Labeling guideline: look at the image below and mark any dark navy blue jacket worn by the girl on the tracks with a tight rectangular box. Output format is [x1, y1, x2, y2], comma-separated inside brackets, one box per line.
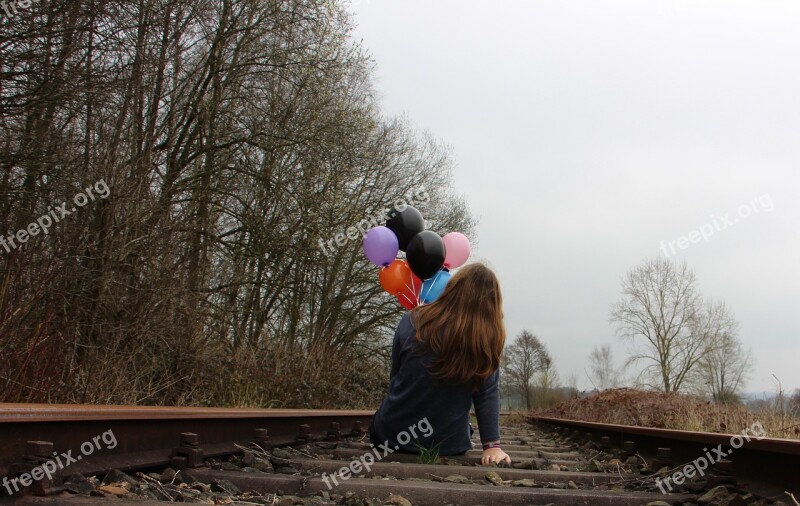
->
[370, 312, 500, 455]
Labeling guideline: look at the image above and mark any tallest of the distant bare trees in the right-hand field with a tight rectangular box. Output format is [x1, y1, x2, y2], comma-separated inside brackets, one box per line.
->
[610, 257, 711, 392]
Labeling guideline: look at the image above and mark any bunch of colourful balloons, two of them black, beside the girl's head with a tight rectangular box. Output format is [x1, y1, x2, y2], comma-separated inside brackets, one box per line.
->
[362, 206, 469, 309]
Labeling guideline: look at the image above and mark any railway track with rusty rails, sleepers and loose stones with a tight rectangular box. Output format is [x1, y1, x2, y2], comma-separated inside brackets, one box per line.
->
[0, 405, 798, 506]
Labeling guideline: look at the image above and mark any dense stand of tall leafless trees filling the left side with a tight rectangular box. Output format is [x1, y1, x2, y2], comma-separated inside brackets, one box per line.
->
[0, 0, 473, 407]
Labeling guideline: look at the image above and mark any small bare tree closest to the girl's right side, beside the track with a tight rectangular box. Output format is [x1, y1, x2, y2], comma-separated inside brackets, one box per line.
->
[502, 330, 553, 410]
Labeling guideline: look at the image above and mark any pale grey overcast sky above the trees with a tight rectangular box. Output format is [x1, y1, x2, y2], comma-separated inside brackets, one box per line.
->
[351, 0, 800, 392]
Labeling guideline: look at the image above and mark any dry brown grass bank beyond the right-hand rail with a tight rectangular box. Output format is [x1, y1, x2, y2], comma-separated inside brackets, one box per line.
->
[536, 388, 800, 439]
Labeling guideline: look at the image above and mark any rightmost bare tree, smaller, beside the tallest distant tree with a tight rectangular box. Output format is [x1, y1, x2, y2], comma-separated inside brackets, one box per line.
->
[695, 301, 752, 403]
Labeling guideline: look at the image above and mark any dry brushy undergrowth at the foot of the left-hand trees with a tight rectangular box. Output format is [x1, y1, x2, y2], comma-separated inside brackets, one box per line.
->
[0, 304, 388, 409]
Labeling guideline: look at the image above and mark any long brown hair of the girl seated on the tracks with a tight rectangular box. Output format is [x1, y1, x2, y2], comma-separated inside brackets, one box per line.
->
[414, 263, 506, 387]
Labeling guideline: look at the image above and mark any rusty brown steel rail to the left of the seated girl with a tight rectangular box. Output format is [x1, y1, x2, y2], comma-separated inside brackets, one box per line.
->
[0, 404, 373, 482]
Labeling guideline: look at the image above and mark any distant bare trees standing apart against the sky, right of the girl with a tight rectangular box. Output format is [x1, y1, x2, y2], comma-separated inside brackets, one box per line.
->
[503, 257, 753, 409]
